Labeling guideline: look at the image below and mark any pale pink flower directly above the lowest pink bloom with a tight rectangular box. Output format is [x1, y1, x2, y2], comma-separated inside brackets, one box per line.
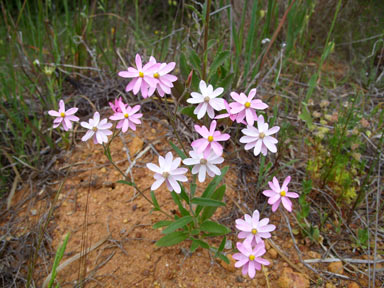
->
[236, 210, 276, 244]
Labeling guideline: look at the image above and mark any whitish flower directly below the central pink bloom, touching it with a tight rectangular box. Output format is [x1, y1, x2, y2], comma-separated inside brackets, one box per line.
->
[183, 148, 224, 183]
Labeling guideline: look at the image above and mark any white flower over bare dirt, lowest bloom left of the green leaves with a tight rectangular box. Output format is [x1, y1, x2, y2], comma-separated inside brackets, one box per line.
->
[147, 152, 188, 194]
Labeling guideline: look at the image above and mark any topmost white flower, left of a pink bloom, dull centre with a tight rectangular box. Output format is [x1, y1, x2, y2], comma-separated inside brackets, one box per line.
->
[187, 80, 225, 119]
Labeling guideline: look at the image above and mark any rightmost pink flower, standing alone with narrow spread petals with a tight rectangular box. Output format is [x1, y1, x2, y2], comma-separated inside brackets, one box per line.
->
[263, 176, 299, 212]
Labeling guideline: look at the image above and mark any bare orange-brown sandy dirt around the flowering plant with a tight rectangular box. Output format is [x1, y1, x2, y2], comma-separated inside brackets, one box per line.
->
[13, 116, 376, 288]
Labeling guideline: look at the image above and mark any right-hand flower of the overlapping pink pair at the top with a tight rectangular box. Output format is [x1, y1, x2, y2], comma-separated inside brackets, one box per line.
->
[144, 56, 177, 97]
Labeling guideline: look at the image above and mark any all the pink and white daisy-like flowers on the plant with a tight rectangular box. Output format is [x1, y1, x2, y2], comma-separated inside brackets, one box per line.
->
[48, 55, 298, 278]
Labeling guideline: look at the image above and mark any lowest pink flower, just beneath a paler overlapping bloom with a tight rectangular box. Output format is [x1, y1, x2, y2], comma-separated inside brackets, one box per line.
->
[233, 241, 269, 278]
